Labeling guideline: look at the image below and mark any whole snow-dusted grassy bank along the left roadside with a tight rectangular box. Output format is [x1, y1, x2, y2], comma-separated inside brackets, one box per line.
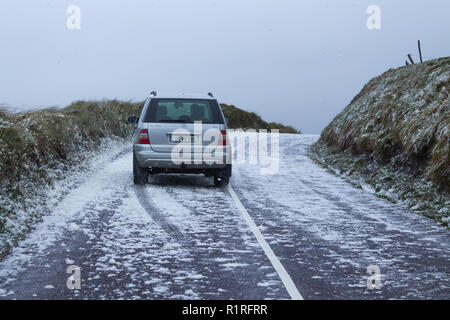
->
[0, 101, 143, 257]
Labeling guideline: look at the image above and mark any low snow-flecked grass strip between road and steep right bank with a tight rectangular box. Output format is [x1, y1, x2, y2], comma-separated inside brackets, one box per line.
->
[310, 144, 450, 227]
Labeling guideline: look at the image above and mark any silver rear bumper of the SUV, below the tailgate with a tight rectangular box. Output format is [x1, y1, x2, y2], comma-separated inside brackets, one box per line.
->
[134, 144, 231, 171]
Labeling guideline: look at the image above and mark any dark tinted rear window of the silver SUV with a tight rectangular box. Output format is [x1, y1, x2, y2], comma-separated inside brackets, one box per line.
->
[144, 98, 224, 124]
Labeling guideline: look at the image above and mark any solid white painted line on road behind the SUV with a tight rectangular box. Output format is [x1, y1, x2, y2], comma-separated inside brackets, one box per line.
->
[228, 185, 303, 300]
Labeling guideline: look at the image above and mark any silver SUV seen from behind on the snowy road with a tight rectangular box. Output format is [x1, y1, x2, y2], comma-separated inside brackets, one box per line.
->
[128, 92, 231, 186]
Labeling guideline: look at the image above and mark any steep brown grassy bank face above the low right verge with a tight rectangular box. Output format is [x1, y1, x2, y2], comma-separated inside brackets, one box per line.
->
[318, 57, 450, 189]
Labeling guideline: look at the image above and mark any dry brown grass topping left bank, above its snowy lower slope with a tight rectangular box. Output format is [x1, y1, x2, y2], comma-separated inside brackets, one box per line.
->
[0, 101, 142, 199]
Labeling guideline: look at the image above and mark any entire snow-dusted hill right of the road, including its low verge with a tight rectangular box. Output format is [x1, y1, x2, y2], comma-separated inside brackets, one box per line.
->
[312, 57, 450, 224]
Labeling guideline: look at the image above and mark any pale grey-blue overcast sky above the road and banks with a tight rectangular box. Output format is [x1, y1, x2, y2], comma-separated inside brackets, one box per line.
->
[0, 0, 450, 133]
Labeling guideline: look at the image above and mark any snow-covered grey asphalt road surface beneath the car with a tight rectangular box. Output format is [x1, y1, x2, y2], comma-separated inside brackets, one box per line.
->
[0, 135, 450, 299]
